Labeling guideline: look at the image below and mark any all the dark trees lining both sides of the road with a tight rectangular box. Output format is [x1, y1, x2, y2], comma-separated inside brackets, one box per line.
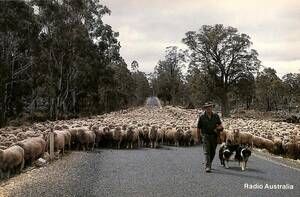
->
[0, 0, 300, 127]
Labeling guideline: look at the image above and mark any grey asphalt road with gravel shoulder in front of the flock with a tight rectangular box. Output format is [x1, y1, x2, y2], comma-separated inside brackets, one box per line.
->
[0, 146, 300, 197]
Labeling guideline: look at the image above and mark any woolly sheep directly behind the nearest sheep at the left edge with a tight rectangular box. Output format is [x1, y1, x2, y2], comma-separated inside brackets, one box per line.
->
[15, 137, 46, 165]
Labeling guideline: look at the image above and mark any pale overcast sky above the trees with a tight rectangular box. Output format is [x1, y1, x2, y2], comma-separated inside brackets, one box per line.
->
[102, 0, 300, 76]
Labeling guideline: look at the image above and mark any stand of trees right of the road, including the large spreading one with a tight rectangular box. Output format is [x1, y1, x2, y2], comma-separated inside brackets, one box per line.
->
[151, 24, 300, 116]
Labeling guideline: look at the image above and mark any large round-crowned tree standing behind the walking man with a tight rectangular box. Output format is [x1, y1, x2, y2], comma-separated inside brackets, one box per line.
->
[183, 24, 260, 116]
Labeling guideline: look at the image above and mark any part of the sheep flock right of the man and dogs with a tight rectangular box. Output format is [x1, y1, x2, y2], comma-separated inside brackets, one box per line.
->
[224, 118, 300, 159]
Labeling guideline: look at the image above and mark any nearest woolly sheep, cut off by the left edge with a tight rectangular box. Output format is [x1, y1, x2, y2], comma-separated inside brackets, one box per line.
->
[0, 145, 24, 179]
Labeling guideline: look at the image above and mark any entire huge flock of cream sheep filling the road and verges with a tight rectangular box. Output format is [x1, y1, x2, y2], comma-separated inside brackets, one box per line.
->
[0, 106, 300, 181]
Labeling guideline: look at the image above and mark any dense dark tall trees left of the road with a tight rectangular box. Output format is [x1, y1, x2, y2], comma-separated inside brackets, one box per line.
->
[0, 0, 150, 127]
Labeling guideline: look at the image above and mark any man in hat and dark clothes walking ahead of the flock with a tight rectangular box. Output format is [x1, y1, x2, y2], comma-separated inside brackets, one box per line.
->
[197, 102, 223, 172]
